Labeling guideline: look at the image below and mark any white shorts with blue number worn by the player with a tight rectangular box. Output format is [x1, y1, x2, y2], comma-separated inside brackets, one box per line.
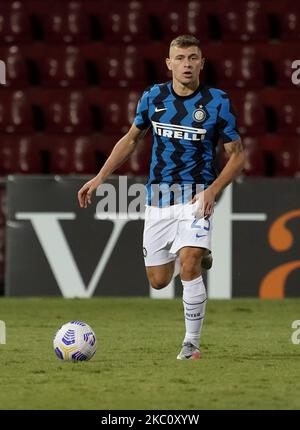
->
[143, 202, 212, 266]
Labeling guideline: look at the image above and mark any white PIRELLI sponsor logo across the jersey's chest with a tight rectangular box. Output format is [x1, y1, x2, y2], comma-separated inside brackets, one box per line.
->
[152, 121, 206, 140]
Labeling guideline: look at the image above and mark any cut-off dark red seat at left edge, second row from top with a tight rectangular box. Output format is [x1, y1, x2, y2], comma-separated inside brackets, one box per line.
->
[0, 45, 29, 88]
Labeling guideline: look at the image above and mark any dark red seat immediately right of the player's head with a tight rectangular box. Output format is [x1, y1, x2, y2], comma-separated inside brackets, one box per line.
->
[212, 44, 264, 89]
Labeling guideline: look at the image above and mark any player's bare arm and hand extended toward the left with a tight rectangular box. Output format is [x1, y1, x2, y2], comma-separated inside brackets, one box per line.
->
[78, 124, 147, 208]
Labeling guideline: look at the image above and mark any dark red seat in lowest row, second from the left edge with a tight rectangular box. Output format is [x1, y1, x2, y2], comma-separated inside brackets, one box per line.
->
[50, 136, 96, 174]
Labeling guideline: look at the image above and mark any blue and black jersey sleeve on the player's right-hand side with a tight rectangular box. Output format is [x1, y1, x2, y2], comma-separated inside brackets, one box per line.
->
[217, 94, 240, 143]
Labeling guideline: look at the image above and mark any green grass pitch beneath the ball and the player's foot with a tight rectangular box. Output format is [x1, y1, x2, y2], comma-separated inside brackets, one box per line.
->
[0, 298, 300, 410]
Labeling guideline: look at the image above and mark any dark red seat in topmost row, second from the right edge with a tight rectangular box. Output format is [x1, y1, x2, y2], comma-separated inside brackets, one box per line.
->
[218, 0, 268, 42]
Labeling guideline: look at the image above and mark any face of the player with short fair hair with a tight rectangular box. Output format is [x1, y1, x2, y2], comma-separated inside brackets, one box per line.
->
[166, 46, 204, 85]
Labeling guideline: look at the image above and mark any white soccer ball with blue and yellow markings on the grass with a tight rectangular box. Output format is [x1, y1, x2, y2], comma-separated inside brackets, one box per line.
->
[53, 321, 97, 361]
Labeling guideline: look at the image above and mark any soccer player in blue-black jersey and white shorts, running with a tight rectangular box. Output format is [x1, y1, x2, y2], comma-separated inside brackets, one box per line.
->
[78, 35, 245, 360]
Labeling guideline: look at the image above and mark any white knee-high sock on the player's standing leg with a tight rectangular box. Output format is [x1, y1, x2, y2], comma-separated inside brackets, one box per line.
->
[181, 276, 207, 347]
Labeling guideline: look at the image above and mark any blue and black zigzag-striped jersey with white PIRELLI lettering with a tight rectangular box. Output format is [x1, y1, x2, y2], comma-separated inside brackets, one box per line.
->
[134, 81, 240, 199]
